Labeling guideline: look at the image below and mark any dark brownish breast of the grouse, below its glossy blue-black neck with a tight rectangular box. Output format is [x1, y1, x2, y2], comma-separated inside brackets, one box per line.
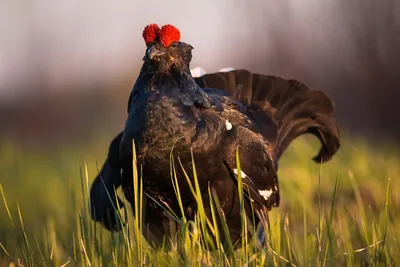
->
[122, 97, 230, 208]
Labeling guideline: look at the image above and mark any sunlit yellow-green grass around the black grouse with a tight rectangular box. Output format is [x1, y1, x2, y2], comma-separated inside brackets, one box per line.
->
[0, 133, 400, 266]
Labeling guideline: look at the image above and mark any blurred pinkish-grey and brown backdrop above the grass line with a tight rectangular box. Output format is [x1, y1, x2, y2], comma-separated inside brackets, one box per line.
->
[0, 0, 400, 149]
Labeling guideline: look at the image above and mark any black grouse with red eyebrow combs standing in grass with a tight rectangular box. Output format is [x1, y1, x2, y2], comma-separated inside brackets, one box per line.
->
[90, 24, 340, 251]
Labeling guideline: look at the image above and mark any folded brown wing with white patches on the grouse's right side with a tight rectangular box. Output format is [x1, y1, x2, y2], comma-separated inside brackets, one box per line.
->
[204, 88, 279, 209]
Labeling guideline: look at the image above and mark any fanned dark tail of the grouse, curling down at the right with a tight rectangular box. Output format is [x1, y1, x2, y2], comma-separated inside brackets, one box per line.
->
[195, 69, 340, 162]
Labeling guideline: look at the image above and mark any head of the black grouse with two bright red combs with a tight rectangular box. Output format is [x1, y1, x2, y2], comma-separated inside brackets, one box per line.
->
[143, 24, 193, 71]
